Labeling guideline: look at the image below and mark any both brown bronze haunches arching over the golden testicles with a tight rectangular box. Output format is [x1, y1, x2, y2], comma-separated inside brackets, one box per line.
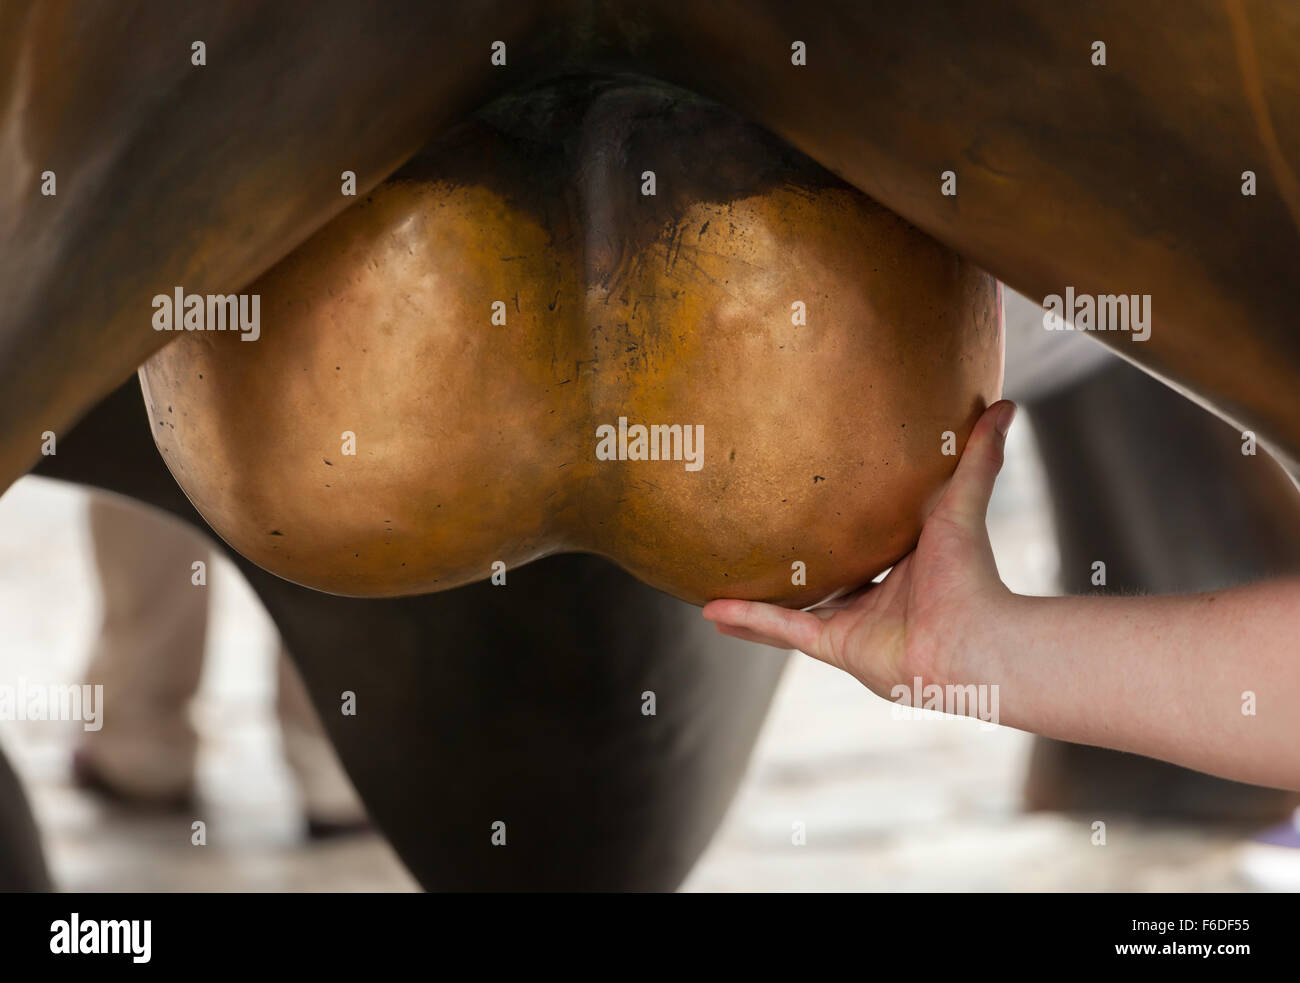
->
[0, 0, 1300, 499]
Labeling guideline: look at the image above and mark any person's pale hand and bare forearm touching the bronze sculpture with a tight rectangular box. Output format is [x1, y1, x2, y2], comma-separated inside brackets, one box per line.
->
[703, 400, 1300, 789]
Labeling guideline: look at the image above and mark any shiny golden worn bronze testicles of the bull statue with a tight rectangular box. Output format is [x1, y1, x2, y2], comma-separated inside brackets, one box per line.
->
[140, 81, 1001, 606]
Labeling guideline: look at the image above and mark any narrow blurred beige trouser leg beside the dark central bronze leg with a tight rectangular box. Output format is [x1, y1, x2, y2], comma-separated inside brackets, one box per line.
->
[276, 650, 368, 837]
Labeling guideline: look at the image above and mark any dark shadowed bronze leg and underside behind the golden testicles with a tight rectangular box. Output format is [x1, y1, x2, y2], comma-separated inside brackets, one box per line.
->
[40, 381, 785, 889]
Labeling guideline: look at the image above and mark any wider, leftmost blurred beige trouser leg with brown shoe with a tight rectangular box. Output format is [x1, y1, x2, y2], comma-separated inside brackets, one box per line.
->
[74, 495, 212, 805]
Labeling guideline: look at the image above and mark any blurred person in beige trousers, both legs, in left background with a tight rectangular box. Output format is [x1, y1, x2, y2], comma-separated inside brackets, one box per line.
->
[73, 495, 367, 837]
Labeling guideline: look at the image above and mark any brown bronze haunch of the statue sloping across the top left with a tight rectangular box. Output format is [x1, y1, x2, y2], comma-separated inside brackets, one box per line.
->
[0, 0, 543, 489]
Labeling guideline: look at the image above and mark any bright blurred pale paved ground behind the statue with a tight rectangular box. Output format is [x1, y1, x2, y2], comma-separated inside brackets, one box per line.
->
[0, 426, 1289, 891]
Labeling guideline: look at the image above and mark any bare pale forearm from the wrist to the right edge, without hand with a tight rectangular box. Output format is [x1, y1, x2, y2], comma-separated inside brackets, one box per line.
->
[963, 579, 1300, 789]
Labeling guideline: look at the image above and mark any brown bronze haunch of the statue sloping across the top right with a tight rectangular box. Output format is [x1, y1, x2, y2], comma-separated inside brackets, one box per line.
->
[626, 0, 1300, 465]
